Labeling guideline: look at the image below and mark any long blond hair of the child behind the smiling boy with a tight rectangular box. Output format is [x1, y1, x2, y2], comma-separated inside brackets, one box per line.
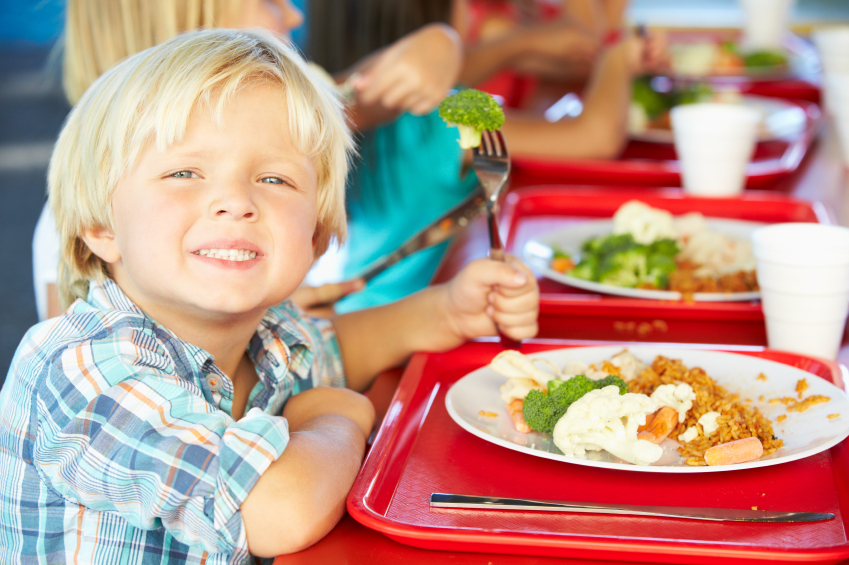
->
[62, 0, 248, 104]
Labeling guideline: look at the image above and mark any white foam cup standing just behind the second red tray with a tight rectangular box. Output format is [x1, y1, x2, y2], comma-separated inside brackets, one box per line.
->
[670, 102, 762, 196]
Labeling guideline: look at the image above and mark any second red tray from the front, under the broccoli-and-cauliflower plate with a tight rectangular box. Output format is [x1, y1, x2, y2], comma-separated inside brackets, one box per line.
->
[501, 186, 830, 345]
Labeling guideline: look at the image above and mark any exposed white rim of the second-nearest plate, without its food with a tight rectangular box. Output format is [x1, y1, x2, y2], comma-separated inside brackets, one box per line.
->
[522, 218, 766, 302]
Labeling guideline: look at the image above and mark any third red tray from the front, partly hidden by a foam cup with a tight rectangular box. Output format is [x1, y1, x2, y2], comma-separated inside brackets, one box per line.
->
[510, 100, 820, 189]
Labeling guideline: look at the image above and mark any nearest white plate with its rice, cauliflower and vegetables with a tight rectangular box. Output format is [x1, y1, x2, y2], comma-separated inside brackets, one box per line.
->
[445, 346, 849, 473]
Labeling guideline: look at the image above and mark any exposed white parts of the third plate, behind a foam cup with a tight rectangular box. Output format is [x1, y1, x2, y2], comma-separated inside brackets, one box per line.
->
[628, 95, 808, 143]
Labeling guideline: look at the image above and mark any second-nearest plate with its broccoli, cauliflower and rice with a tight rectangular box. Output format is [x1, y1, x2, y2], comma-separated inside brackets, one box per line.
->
[523, 200, 765, 302]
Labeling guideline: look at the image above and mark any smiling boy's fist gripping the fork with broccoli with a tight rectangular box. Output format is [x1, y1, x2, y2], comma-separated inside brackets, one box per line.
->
[447, 256, 539, 342]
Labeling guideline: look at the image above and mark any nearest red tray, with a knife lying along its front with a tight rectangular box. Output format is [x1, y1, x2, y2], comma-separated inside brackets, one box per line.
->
[348, 341, 849, 564]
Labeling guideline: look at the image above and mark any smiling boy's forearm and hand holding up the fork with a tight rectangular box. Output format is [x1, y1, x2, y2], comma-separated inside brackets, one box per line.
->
[333, 259, 539, 390]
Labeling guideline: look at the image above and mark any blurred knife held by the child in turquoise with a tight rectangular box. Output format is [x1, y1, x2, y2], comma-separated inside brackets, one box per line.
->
[356, 186, 486, 282]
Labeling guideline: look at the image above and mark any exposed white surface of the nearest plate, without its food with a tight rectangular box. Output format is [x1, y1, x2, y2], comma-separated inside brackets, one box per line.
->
[445, 345, 849, 473]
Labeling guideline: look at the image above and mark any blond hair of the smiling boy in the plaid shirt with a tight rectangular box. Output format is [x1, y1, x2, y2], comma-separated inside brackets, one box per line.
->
[47, 29, 353, 307]
